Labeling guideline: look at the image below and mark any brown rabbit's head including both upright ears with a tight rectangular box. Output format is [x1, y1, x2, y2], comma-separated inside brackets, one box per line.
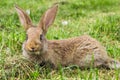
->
[15, 4, 58, 55]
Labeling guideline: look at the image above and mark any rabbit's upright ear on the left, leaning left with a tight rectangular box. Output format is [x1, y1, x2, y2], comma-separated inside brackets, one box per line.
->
[15, 6, 32, 30]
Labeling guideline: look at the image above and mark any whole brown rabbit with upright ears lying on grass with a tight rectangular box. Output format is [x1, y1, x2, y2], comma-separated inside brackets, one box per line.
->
[15, 4, 120, 69]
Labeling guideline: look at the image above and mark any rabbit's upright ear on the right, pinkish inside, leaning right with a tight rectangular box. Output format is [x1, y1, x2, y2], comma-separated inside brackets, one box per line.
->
[38, 4, 58, 34]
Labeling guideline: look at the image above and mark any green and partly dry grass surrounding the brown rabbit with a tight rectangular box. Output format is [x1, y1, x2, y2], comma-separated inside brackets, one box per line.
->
[0, 0, 120, 80]
